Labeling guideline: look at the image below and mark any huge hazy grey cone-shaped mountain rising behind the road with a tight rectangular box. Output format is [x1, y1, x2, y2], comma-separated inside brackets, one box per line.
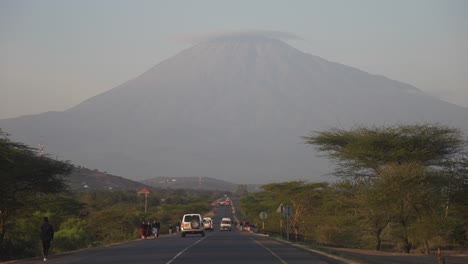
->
[0, 34, 468, 183]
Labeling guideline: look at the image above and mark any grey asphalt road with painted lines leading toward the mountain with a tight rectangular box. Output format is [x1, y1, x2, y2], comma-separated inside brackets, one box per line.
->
[15, 206, 341, 264]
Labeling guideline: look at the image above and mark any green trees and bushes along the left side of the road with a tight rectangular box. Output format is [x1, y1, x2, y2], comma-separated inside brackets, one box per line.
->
[0, 131, 219, 260]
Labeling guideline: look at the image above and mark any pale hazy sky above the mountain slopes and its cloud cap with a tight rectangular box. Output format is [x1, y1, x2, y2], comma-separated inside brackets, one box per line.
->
[0, 0, 468, 118]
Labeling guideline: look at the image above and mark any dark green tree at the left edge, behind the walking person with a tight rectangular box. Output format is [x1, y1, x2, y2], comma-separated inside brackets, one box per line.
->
[0, 131, 72, 251]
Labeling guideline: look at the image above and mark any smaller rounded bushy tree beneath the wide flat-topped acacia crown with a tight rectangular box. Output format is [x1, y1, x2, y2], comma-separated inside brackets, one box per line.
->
[376, 162, 443, 254]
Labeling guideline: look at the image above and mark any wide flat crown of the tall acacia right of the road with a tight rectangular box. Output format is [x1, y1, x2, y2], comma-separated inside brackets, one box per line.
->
[304, 124, 465, 176]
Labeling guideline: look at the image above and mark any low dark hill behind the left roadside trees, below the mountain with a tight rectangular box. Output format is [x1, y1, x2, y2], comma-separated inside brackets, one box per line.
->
[66, 167, 148, 191]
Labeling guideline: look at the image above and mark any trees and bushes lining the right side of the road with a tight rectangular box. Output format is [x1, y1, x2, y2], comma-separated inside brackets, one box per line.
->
[238, 124, 468, 254]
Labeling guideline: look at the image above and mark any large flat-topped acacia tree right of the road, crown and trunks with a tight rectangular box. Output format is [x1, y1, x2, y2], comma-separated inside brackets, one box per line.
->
[304, 124, 466, 252]
